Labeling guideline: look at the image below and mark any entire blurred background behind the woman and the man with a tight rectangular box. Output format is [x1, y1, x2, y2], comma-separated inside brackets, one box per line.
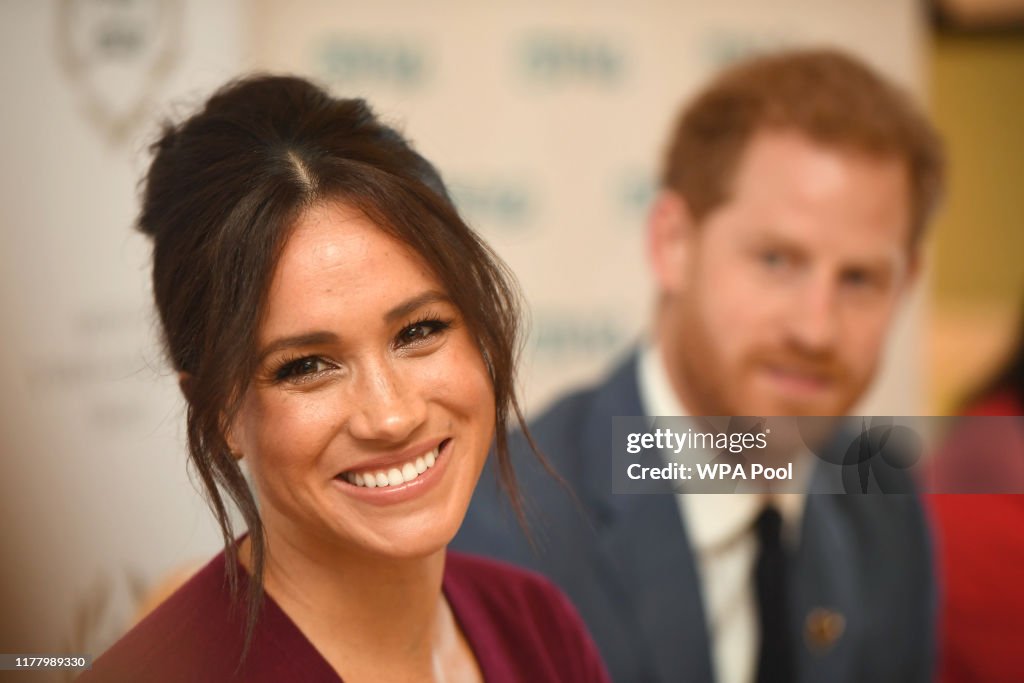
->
[0, 0, 1024, 680]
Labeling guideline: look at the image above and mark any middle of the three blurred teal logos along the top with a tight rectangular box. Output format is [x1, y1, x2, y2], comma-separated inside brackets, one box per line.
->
[519, 33, 627, 86]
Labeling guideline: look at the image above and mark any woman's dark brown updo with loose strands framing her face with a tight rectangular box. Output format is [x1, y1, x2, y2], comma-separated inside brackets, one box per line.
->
[138, 76, 528, 648]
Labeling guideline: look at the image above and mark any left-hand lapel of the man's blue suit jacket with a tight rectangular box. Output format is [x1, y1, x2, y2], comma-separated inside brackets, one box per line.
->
[582, 355, 714, 683]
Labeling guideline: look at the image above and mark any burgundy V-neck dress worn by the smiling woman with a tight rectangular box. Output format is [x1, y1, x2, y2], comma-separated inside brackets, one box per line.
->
[78, 552, 609, 683]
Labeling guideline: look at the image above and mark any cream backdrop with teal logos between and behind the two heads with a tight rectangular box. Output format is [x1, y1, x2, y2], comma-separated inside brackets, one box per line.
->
[250, 0, 923, 413]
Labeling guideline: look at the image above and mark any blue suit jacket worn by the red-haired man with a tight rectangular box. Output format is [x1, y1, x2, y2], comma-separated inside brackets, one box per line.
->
[453, 355, 935, 683]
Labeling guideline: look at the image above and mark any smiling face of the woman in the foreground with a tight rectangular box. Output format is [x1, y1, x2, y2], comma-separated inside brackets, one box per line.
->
[234, 202, 495, 561]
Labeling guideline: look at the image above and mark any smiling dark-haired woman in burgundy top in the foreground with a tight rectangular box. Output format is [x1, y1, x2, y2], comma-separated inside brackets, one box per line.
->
[81, 77, 606, 681]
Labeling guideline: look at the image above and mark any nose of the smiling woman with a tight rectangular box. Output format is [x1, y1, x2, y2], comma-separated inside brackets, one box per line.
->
[348, 359, 427, 442]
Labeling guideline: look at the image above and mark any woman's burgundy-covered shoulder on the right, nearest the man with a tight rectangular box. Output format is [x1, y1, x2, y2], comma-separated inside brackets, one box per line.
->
[444, 552, 608, 683]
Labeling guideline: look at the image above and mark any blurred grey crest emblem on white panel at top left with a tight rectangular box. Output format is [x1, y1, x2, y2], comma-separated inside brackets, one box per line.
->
[55, 0, 182, 144]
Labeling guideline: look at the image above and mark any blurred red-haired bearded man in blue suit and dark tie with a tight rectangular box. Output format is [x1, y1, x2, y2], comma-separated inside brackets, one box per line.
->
[455, 50, 942, 683]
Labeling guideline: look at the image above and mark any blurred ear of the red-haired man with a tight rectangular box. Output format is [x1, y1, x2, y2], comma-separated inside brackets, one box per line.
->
[647, 189, 696, 294]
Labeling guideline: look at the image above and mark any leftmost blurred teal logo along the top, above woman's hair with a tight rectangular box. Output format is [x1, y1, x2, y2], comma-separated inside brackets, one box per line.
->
[313, 35, 429, 89]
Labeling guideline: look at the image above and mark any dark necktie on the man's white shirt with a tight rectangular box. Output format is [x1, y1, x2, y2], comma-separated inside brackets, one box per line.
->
[754, 505, 796, 683]
